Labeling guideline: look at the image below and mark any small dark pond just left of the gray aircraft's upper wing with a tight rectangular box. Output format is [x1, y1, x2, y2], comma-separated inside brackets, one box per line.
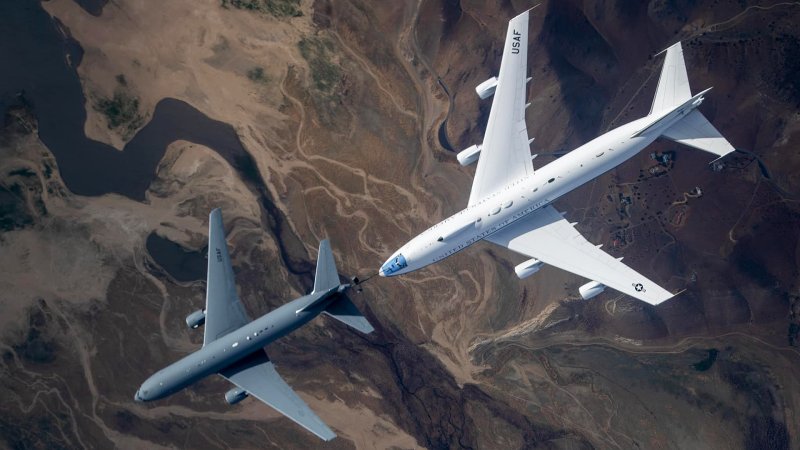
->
[147, 233, 208, 281]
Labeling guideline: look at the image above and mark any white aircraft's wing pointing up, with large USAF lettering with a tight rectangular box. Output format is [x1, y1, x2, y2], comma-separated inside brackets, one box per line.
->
[469, 11, 533, 206]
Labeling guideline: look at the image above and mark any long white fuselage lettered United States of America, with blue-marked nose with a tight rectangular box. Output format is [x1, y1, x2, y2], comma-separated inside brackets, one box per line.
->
[379, 90, 707, 276]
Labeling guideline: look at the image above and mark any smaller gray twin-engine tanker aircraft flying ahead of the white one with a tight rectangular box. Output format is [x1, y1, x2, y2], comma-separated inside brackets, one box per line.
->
[134, 209, 373, 441]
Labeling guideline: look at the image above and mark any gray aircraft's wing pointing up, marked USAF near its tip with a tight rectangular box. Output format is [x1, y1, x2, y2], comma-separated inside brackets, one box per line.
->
[203, 208, 250, 345]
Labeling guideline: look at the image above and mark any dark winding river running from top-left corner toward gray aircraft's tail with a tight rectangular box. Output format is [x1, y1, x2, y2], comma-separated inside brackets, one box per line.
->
[0, 0, 313, 285]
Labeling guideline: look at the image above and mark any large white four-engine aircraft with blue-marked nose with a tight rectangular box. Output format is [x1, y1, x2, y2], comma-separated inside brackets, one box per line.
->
[379, 11, 734, 305]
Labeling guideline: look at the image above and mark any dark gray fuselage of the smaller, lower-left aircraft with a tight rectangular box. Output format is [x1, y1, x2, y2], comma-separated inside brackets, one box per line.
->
[134, 285, 347, 401]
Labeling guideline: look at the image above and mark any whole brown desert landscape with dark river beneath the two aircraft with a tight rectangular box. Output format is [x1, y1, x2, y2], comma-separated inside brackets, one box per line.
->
[0, 0, 800, 449]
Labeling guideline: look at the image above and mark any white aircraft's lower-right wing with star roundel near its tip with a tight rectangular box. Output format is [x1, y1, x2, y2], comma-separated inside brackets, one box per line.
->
[485, 206, 673, 305]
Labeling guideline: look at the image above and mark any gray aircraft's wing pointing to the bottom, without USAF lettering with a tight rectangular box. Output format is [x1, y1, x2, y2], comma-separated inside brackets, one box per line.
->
[220, 350, 336, 441]
